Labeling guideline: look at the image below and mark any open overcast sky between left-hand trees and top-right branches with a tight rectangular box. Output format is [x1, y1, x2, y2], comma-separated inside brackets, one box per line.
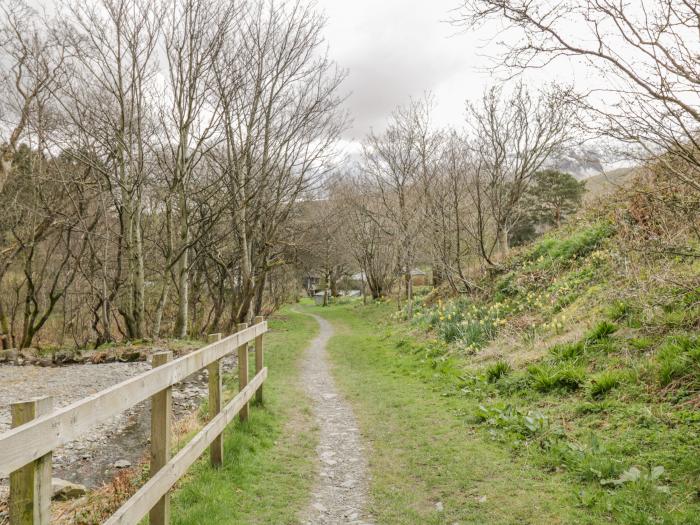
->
[316, 0, 588, 145]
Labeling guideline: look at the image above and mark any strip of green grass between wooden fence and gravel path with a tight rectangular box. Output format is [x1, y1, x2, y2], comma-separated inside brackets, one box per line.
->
[172, 309, 317, 525]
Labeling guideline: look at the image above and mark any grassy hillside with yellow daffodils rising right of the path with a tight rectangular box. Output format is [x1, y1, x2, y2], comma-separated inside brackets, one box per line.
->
[396, 183, 700, 523]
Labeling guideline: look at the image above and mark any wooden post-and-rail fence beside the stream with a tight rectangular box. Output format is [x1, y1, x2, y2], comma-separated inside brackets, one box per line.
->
[0, 317, 267, 525]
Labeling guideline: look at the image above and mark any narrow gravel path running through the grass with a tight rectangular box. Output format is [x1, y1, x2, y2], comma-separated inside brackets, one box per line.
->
[301, 314, 369, 525]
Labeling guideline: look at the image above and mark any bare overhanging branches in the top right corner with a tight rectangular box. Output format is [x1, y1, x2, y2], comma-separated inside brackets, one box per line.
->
[456, 0, 700, 191]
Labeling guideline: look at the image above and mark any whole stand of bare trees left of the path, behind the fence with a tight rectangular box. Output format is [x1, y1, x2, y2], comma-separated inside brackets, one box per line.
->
[0, 0, 345, 347]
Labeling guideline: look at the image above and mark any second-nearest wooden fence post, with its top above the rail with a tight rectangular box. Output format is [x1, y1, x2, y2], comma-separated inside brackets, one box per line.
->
[149, 352, 173, 525]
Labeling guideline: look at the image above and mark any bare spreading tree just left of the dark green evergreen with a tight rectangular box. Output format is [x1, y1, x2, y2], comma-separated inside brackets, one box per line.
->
[468, 84, 575, 265]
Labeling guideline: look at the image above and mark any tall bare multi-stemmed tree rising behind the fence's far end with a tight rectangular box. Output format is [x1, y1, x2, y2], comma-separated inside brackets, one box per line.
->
[212, 1, 345, 322]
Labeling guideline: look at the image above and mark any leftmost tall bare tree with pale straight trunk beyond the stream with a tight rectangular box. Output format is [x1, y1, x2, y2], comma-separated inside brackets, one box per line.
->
[57, 0, 160, 338]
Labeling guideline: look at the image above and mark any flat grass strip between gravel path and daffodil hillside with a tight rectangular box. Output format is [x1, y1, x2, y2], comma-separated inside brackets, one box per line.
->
[307, 304, 599, 524]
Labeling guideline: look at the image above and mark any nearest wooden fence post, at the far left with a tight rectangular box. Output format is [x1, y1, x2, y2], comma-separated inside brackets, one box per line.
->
[9, 397, 53, 525]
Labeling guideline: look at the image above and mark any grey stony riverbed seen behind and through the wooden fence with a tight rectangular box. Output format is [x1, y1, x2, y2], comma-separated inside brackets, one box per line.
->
[0, 350, 236, 500]
